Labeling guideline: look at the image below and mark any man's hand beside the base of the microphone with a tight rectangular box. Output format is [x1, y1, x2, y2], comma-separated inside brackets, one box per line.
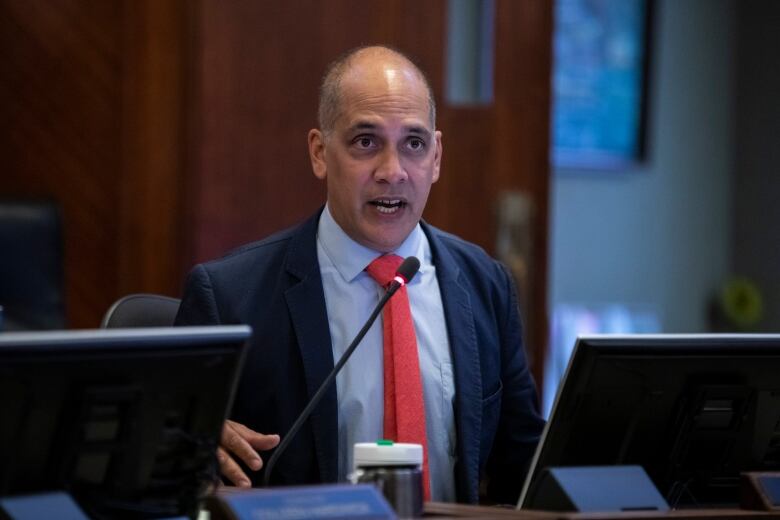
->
[217, 421, 279, 487]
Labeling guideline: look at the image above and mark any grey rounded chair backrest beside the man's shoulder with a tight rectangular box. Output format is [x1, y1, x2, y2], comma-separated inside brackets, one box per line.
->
[100, 293, 181, 329]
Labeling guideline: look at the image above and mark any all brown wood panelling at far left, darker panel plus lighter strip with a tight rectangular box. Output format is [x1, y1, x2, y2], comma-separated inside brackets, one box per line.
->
[0, 0, 189, 327]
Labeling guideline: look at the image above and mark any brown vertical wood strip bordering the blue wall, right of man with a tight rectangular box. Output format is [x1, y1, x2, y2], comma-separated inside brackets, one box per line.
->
[493, 0, 553, 374]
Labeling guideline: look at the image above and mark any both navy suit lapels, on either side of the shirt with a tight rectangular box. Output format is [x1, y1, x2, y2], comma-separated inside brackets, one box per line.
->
[278, 211, 482, 492]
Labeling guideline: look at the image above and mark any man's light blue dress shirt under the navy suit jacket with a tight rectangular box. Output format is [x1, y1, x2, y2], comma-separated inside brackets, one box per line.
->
[317, 206, 456, 502]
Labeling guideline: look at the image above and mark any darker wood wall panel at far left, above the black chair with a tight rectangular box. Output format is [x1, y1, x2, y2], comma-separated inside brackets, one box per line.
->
[0, 0, 122, 326]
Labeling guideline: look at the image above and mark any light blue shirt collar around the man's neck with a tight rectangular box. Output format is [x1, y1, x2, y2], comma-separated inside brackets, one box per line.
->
[317, 204, 431, 283]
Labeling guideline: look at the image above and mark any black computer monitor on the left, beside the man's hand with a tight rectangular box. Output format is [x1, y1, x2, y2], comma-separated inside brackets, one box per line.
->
[0, 326, 251, 518]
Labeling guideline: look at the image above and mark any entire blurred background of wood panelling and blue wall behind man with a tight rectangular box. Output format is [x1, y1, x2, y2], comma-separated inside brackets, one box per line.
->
[0, 0, 780, 406]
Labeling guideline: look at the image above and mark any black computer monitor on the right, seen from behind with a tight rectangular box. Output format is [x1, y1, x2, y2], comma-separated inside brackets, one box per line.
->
[519, 334, 780, 507]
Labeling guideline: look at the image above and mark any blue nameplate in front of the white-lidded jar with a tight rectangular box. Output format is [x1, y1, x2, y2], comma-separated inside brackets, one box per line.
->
[209, 484, 396, 520]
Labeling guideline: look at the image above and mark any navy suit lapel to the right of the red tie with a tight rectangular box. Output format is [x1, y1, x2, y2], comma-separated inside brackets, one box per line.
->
[422, 222, 482, 502]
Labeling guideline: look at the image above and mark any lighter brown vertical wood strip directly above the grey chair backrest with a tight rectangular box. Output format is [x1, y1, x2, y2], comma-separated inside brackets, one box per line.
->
[117, 0, 192, 296]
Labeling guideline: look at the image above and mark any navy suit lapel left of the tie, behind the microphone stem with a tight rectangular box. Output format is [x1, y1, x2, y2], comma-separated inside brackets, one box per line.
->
[284, 211, 338, 482]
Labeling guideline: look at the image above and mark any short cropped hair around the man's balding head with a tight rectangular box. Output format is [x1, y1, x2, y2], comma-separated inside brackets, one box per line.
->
[317, 45, 436, 134]
